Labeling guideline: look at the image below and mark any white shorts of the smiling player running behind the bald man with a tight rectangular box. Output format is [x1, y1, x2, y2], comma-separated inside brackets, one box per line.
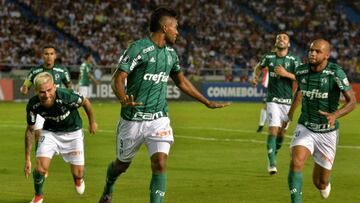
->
[266, 102, 291, 129]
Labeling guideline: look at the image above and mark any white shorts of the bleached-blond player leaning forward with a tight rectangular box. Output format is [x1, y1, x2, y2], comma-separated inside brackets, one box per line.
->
[36, 129, 85, 165]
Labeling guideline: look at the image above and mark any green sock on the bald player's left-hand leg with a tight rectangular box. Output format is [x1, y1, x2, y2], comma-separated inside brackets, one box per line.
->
[288, 171, 303, 203]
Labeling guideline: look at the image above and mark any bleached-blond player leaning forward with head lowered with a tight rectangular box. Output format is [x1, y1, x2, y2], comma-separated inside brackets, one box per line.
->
[24, 72, 97, 203]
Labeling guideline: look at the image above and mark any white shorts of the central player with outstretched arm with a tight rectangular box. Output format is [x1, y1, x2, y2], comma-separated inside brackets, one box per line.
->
[116, 117, 174, 162]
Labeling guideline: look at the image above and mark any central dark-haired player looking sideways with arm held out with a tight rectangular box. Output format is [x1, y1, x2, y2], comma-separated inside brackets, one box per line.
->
[99, 7, 229, 203]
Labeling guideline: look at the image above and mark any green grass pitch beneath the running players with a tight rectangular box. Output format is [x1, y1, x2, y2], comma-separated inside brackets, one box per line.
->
[0, 102, 360, 203]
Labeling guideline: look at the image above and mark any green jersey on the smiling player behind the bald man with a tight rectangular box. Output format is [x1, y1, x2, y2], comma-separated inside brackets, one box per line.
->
[260, 52, 301, 105]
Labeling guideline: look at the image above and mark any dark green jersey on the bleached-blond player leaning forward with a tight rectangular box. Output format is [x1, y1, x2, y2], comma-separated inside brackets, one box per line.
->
[26, 88, 84, 132]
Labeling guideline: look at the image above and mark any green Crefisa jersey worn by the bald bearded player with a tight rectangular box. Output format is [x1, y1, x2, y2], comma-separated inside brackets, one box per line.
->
[296, 62, 351, 132]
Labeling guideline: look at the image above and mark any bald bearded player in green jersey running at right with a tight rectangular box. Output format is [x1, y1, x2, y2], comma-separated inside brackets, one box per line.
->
[288, 39, 356, 203]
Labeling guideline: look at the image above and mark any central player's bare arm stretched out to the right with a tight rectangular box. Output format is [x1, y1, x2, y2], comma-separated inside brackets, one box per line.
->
[171, 72, 230, 109]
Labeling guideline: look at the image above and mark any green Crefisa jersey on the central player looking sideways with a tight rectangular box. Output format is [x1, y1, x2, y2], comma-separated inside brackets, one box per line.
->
[118, 38, 181, 121]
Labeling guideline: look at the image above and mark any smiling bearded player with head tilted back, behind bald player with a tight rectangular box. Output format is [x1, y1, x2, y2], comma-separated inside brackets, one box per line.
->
[252, 33, 300, 175]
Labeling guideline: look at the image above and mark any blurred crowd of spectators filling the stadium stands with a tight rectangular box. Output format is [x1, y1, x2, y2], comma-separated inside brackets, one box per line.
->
[0, 0, 360, 81]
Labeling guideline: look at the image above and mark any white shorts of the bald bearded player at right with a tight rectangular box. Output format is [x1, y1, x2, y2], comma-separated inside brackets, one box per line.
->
[290, 124, 339, 170]
